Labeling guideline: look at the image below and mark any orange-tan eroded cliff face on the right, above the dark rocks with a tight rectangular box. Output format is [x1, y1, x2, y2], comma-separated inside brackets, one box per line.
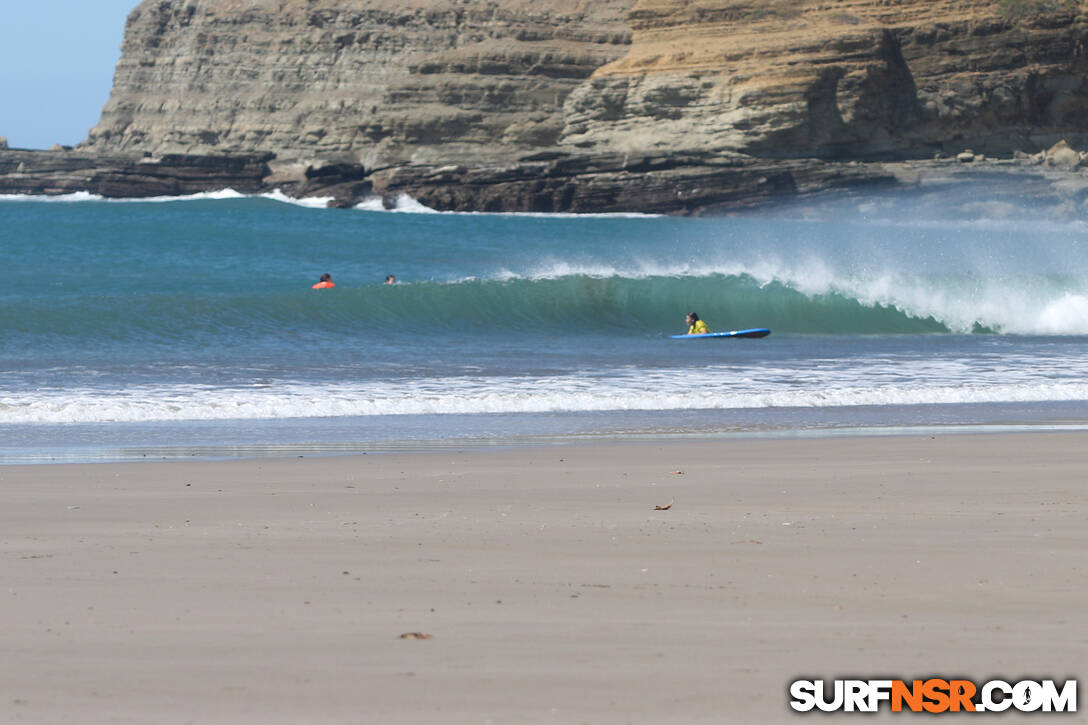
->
[562, 0, 1088, 158]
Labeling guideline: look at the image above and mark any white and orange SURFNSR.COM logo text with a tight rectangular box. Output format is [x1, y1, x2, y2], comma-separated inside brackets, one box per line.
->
[790, 677, 1077, 713]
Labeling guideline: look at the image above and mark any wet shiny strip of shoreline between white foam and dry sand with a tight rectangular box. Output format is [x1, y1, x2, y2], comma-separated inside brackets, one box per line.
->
[6, 401, 1088, 468]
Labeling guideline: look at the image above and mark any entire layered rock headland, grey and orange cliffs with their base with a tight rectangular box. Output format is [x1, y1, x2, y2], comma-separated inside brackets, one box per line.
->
[6, 0, 1088, 213]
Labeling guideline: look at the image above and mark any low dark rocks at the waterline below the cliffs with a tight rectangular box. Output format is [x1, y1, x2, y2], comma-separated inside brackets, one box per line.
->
[0, 144, 893, 214]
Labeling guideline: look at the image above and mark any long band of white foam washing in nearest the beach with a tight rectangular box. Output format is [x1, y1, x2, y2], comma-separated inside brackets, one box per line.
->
[6, 358, 1088, 425]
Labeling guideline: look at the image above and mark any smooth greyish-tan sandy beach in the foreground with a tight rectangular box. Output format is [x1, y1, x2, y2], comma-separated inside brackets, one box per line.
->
[0, 433, 1088, 723]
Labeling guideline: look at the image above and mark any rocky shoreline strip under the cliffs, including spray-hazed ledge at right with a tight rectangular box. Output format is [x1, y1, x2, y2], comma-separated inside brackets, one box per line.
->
[0, 148, 1086, 217]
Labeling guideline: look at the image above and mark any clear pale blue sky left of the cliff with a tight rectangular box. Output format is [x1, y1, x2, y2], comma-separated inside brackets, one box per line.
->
[0, 0, 139, 148]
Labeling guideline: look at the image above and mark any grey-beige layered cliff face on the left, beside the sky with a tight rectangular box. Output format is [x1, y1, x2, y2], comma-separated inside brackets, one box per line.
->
[84, 0, 632, 167]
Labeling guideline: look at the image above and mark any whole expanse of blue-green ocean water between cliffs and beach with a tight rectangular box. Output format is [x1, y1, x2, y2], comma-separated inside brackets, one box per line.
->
[0, 185, 1088, 463]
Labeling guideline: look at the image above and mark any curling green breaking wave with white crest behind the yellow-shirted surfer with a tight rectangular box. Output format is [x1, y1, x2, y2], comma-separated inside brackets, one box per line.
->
[8, 269, 1088, 340]
